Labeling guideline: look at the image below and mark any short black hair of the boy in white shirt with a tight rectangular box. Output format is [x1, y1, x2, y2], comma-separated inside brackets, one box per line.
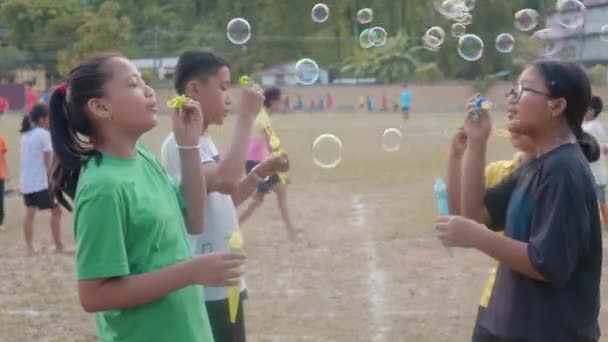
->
[173, 49, 230, 95]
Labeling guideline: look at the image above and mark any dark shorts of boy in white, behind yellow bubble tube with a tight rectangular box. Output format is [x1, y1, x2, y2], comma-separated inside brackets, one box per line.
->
[205, 291, 247, 342]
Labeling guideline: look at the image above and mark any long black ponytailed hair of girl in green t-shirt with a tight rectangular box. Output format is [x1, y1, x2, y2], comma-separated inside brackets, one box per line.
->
[50, 53, 123, 210]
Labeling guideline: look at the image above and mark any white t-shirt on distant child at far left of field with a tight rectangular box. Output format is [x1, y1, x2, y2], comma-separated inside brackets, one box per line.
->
[19, 127, 53, 194]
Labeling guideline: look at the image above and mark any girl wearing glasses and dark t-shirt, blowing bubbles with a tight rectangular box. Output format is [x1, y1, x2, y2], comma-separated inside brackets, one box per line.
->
[436, 61, 602, 342]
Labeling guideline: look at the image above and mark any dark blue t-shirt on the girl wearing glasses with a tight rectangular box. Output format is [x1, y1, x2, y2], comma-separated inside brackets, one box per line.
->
[479, 144, 602, 342]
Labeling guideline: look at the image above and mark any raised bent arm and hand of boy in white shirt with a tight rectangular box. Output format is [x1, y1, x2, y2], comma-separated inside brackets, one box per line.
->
[203, 87, 264, 195]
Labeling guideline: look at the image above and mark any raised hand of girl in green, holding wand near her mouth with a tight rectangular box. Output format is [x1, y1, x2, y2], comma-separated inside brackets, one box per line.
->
[173, 98, 203, 146]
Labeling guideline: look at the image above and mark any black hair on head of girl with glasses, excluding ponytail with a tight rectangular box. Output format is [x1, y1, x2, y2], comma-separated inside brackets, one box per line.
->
[533, 60, 591, 140]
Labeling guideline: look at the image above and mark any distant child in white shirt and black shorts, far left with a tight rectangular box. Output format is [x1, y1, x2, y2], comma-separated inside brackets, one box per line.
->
[19, 104, 65, 255]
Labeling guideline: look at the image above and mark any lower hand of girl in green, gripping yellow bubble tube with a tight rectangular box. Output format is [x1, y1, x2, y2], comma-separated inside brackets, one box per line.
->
[190, 252, 245, 287]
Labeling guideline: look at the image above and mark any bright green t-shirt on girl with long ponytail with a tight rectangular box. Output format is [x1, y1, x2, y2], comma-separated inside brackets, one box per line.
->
[74, 146, 213, 342]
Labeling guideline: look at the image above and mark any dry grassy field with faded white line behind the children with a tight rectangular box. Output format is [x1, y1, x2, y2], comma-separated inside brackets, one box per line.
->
[0, 114, 608, 342]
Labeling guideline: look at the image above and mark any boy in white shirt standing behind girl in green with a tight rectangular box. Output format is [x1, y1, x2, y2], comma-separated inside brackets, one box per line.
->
[161, 50, 289, 342]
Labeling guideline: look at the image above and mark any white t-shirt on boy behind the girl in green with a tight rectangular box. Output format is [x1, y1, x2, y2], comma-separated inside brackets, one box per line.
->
[160, 133, 246, 301]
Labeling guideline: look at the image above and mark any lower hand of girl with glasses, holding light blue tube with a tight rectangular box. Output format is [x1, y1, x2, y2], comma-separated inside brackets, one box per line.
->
[435, 216, 491, 248]
